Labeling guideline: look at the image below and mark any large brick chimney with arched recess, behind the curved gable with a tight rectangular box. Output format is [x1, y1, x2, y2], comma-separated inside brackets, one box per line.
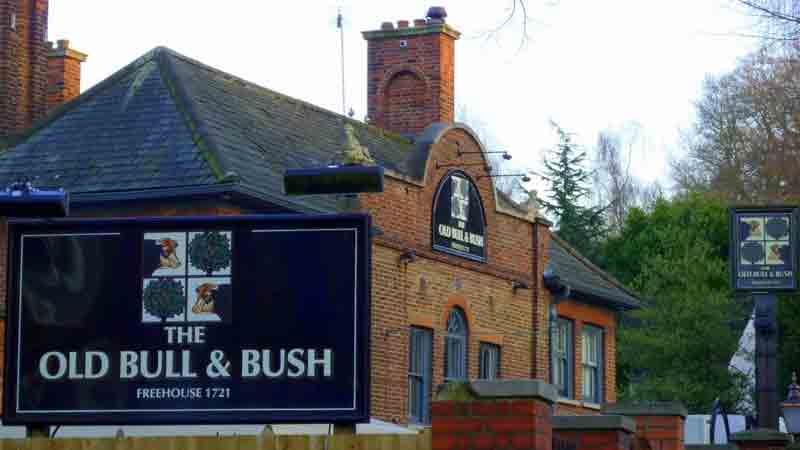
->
[363, 7, 461, 135]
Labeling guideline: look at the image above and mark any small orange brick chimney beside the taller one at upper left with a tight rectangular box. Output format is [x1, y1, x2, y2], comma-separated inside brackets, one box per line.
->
[47, 39, 86, 111]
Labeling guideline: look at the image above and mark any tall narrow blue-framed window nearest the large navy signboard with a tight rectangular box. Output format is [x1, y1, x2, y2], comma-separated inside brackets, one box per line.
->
[408, 327, 433, 423]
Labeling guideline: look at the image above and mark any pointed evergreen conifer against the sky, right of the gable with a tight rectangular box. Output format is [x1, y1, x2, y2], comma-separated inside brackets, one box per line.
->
[542, 123, 605, 258]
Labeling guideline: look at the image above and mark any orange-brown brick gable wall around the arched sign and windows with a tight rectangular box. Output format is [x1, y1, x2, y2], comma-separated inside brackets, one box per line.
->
[361, 129, 546, 423]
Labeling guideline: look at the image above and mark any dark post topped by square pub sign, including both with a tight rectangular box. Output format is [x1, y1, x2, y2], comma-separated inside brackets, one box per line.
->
[729, 207, 798, 430]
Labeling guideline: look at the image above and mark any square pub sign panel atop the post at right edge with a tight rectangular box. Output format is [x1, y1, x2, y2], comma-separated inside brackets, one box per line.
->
[729, 207, 798, 291]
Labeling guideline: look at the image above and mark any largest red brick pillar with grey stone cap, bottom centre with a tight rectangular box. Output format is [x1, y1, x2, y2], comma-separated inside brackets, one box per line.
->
[431, 380, 556, 450]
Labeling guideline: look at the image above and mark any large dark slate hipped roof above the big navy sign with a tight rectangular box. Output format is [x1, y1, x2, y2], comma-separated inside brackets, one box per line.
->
[0, 47, 418, 212]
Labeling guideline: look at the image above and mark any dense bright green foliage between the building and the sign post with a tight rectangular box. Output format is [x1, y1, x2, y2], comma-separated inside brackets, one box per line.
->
[603, 195, 749, 412]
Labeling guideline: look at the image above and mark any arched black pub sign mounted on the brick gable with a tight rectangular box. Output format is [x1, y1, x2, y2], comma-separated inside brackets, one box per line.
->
[431, 171, 486, 262]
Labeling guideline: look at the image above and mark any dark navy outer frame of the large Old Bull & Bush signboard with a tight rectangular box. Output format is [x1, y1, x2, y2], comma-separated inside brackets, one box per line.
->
[3, 214, 372, 425]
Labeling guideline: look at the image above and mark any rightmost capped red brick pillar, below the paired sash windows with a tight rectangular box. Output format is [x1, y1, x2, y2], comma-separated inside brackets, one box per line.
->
[603, 402, 687, 450]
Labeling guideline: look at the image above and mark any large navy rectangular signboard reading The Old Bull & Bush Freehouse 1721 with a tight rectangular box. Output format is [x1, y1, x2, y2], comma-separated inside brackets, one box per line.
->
[3, 215, 371, 425]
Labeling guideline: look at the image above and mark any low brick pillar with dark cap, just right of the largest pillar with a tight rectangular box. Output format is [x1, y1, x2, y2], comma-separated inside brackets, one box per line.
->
[553, 416, 636, 450]
